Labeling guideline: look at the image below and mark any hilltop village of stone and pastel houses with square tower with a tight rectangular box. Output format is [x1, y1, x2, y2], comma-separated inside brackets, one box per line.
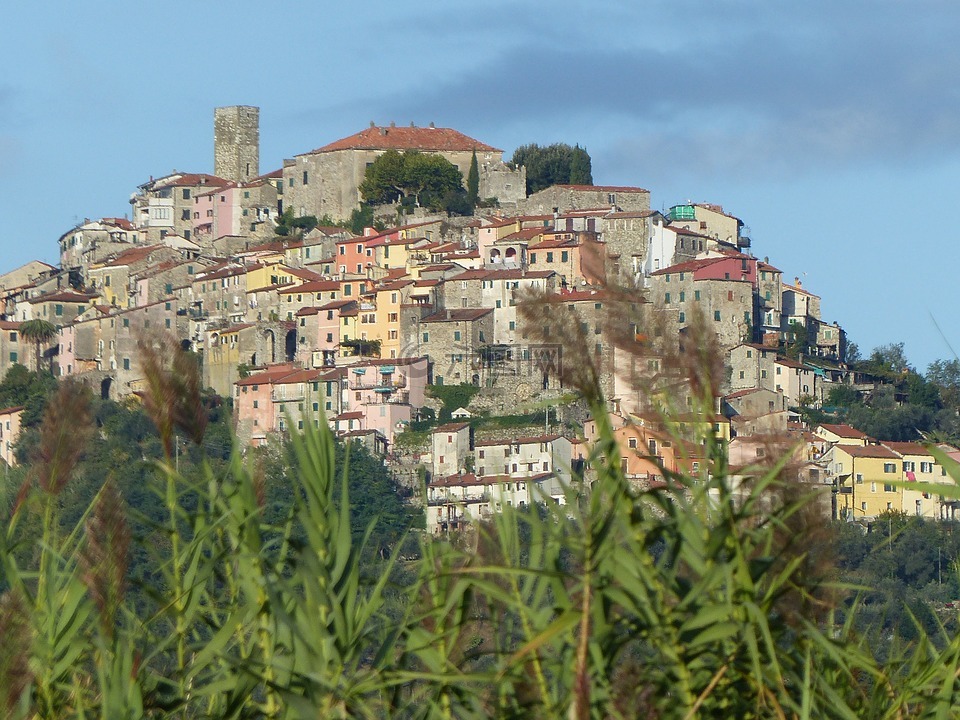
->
[0, 106, 955, 531]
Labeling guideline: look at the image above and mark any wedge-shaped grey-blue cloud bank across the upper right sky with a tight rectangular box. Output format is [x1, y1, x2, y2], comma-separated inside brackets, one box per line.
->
[338, 0, 960, 183]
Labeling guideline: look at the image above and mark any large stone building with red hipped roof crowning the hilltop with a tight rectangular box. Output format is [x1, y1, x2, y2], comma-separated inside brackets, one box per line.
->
[283, 123, 526, 220]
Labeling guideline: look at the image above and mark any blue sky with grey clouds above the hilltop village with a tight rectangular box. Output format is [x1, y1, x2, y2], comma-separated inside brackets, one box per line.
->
[0, 0, 960, 371]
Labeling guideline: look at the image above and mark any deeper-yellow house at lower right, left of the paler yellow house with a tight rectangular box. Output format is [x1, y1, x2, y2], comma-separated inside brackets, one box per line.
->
[827, 445, 903, 520]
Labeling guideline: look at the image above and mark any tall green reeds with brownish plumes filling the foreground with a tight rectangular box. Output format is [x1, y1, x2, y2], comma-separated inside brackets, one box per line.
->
[0, 328, 960, 720]
